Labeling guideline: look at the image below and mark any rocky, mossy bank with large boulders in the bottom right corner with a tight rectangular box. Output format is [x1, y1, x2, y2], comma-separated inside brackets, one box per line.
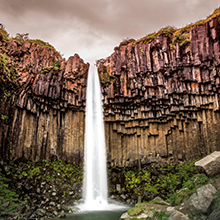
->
[120, 152, 220, 220]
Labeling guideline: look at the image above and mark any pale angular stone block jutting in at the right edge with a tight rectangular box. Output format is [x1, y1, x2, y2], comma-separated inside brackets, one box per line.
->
[195, 151, 220, 176]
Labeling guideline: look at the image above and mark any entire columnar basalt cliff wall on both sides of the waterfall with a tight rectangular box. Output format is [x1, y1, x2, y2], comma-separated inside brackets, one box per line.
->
[0, 9, 220, 167]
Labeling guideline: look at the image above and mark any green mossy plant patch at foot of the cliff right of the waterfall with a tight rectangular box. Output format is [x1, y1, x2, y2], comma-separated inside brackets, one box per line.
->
[124, 162, 197, 201]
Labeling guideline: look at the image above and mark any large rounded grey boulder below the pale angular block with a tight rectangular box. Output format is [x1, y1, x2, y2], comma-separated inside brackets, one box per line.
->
[187, 184, 217, 213]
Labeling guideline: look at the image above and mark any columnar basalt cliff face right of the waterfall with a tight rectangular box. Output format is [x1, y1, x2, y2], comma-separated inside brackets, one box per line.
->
[97, 9, 220, 166]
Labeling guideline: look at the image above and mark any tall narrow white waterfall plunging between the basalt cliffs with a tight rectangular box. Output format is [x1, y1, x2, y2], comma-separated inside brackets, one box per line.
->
[80, 66, 108, 210]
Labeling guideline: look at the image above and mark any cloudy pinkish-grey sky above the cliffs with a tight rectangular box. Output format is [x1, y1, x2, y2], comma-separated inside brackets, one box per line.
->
[0, 0, 220, 63]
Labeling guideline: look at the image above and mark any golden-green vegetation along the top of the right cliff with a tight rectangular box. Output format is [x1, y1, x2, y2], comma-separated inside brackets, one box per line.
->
[115, 7, 220, 50]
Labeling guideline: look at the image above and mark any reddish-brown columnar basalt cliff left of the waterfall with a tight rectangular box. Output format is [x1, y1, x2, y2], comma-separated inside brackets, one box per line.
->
[0, 36, 89, 164]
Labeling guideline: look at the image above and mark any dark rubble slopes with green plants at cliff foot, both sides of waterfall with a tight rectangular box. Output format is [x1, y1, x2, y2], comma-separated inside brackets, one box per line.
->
[0, 157, 202, 220]
